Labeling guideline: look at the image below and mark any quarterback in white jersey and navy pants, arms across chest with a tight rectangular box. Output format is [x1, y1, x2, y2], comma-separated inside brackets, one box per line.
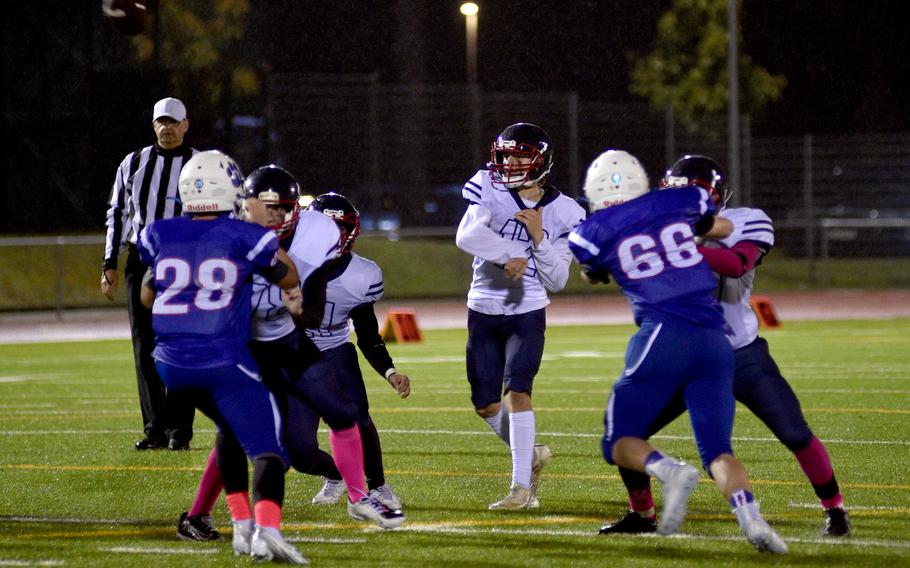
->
[455, 123, 585, 510]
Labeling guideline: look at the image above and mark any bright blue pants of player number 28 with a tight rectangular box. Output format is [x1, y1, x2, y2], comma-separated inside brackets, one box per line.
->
[156, 353, 288, 464]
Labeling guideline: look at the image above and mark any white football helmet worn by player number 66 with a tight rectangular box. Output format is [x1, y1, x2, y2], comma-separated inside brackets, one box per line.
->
[584, 150, 649, 213]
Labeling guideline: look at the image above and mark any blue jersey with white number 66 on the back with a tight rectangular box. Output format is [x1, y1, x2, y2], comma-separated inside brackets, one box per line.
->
[569, 187, 726, 329]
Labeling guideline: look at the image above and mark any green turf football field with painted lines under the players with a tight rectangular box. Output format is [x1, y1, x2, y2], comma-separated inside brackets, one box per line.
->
[0, 319, 910, 568]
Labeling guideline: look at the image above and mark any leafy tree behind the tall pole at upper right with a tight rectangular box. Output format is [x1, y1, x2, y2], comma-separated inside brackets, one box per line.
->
[630, 0, 787, 133]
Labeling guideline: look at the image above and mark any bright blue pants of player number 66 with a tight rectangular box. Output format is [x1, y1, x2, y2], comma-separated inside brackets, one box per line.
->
[601, 316, 735, 468]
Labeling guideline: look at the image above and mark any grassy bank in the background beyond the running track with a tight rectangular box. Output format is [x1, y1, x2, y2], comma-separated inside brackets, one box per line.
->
[0, 237, 910, 311]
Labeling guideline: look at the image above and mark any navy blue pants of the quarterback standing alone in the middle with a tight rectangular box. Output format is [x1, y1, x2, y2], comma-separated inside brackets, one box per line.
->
[467, 308, 547, 408]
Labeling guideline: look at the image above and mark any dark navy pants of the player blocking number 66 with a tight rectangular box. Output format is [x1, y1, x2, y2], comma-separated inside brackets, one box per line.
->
[648, 337, 814, 452]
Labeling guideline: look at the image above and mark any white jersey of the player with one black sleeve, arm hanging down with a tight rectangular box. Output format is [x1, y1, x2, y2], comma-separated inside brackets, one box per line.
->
[306, 253, 383, 351]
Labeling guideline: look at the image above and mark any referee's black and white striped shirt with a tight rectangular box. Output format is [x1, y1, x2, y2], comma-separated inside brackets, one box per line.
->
[104, 144, 197, 270]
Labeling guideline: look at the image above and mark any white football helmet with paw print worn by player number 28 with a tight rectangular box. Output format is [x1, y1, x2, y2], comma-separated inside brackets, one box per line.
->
[178, 150, 243, 213]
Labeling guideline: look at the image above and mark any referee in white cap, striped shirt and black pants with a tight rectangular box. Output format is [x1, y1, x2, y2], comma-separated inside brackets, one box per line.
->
[101, 98, 196, 450]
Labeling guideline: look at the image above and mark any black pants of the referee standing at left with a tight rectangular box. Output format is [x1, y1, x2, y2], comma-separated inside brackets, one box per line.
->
[124, 245, 196, 444]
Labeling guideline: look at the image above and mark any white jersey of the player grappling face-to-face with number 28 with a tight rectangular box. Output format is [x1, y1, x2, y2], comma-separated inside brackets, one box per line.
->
[251, 210, 341, 341]
